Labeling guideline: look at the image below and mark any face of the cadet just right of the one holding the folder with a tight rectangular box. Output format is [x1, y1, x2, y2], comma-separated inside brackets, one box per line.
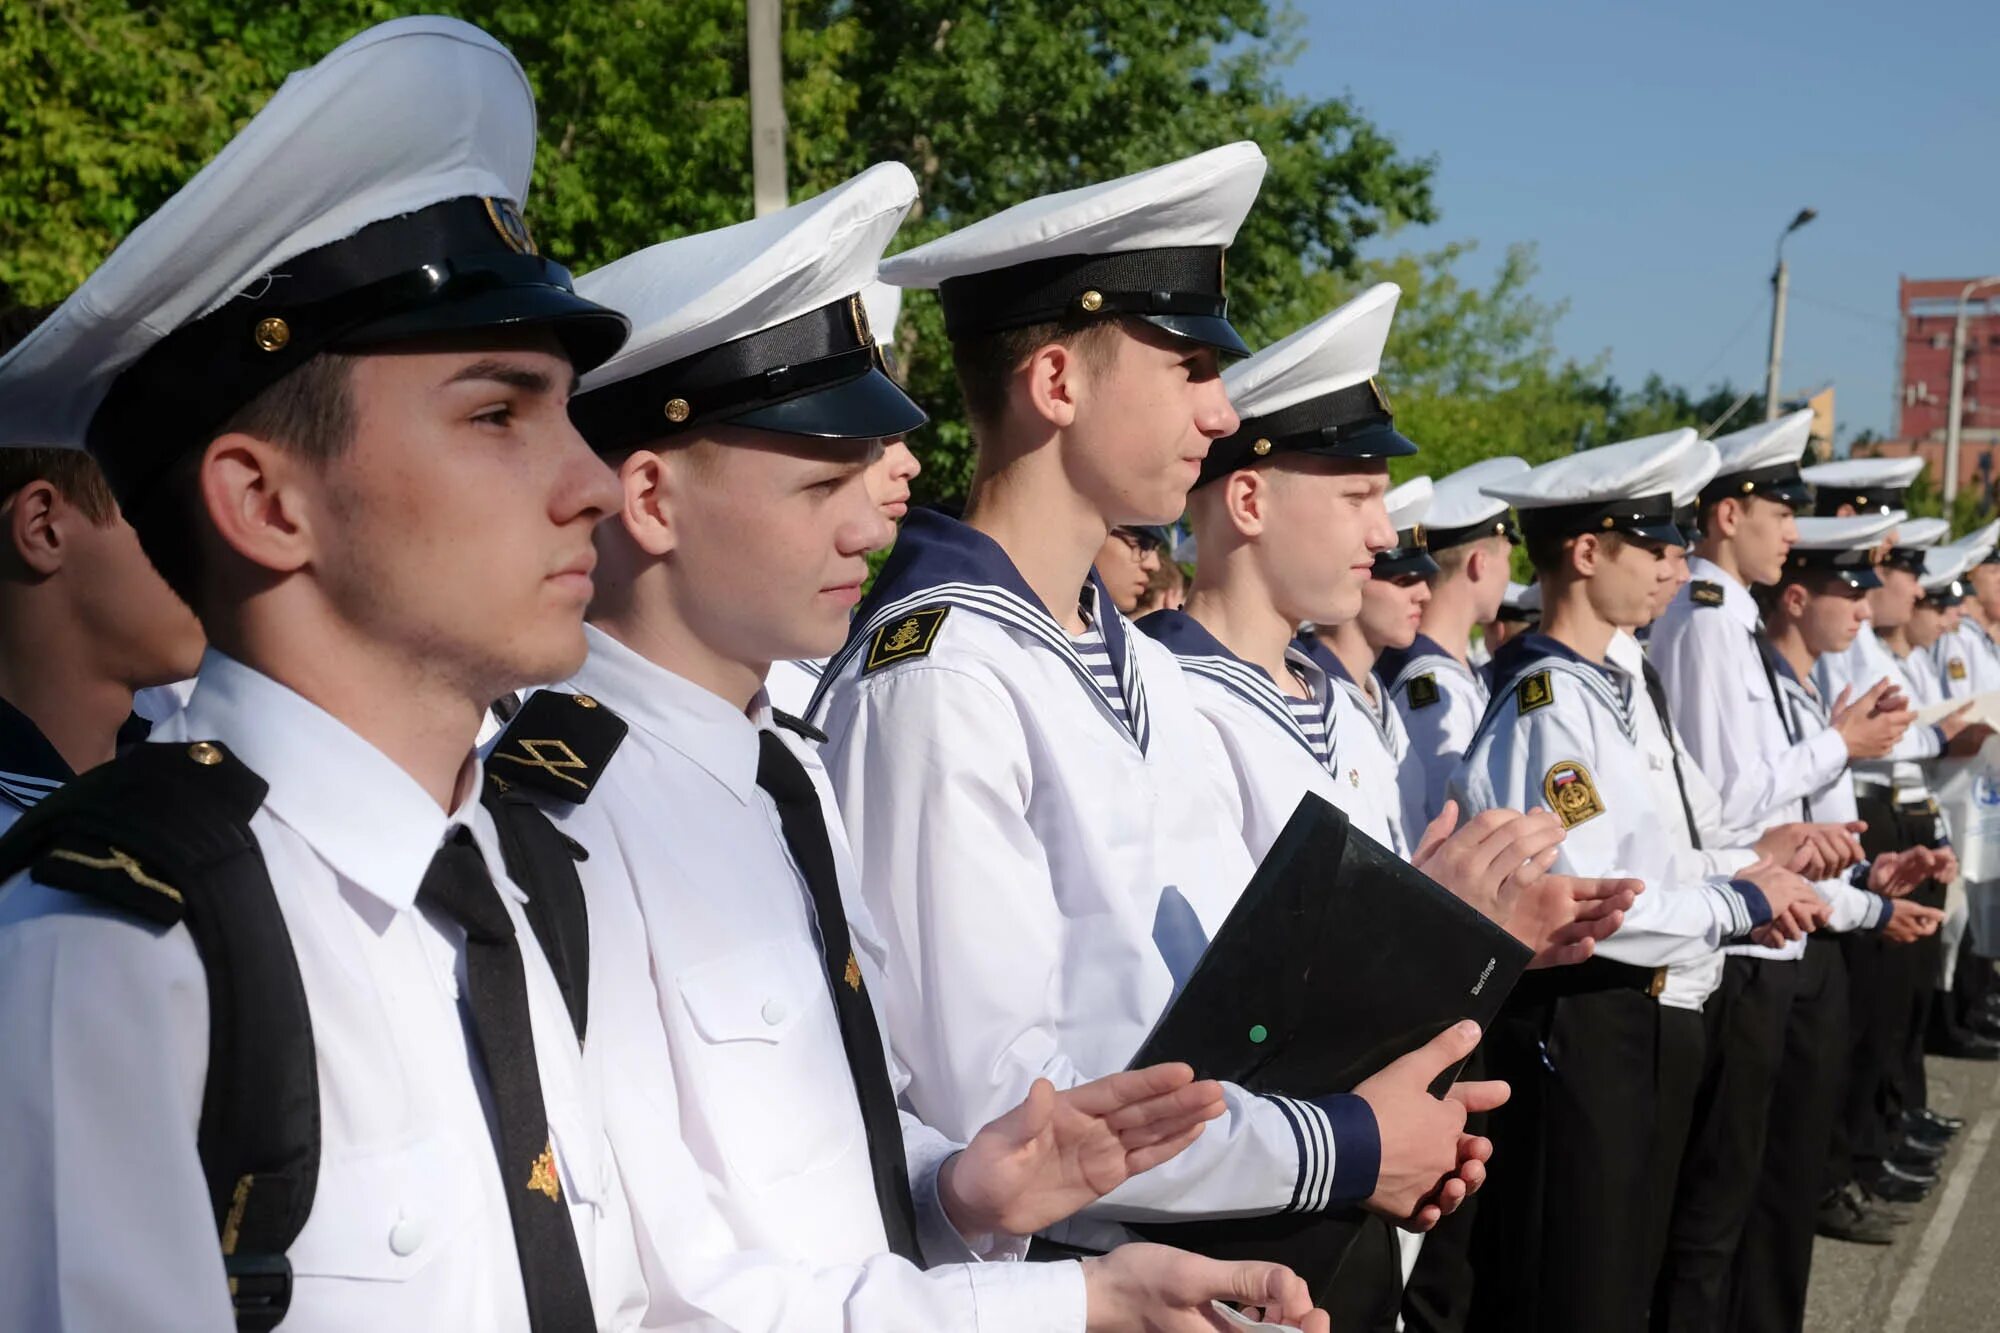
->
[1256, 454, 1396, 624]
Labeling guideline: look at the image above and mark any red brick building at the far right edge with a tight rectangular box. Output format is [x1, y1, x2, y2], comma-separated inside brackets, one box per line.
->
[1884, 278, 2000, 488]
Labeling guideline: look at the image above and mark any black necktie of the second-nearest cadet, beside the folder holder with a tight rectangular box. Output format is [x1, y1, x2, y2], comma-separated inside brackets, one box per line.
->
[756, 731, 924, 1267]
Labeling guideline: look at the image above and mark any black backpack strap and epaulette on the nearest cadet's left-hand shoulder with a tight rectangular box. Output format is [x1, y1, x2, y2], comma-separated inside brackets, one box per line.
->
[0, 741, 320, 1329]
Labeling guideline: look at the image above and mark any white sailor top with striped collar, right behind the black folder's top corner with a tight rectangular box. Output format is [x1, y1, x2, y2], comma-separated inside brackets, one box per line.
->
[1140, 610, 1394, 861]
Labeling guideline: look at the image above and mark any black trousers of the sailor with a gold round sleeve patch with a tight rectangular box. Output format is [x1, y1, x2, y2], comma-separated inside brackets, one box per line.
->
[1466, 959, 1700, 1333]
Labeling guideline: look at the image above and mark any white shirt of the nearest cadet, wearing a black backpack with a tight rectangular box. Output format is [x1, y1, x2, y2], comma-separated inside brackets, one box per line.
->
[0, 650, 644, 1333]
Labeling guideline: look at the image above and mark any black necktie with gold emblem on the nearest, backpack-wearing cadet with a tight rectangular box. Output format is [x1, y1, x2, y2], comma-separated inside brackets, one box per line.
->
[416, 827, 596, 1333]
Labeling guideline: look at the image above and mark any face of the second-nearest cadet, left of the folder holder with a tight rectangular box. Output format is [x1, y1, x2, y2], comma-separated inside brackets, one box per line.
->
[644, 426, 896, 669]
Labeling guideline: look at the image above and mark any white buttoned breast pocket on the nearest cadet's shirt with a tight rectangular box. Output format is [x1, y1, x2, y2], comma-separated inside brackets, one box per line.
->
[290, 1137, 476, 1283]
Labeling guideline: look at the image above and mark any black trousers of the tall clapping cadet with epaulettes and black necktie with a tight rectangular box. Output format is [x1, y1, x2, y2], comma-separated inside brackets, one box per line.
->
[1652, 955, 1800, 1333]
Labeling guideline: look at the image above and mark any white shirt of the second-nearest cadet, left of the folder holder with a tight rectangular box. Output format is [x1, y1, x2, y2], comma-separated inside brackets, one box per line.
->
[524, 626, 1084, 1333]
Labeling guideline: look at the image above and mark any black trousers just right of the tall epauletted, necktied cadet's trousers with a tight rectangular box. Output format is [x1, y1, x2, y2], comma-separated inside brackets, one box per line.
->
[1726, 935, 1848, 1333]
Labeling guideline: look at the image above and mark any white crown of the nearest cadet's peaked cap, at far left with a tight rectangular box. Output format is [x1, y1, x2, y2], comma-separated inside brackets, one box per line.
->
[0, 16, 534, 446]
